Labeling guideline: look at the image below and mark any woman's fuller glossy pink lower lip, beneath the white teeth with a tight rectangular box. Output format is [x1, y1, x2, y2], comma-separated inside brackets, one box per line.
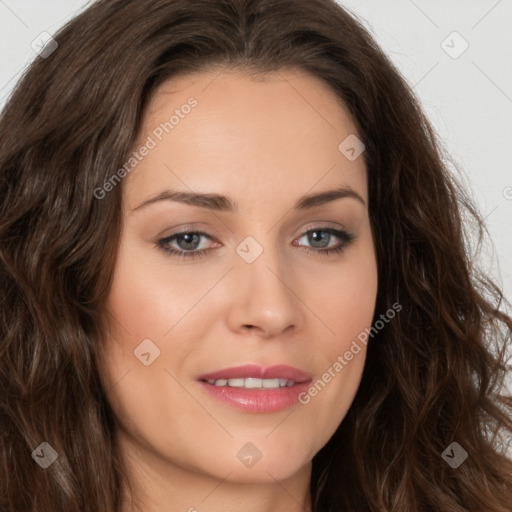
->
[199, 381, 310, 412]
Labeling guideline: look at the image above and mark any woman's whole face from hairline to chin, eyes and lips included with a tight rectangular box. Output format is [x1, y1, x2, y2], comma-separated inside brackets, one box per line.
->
[100, 71, 377, 488]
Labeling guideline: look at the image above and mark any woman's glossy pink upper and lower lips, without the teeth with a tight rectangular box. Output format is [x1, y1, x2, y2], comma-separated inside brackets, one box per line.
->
[198, 365, 312, 413]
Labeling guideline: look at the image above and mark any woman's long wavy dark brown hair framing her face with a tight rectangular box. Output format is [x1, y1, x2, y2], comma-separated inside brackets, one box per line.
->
[0, 0, 512, 512]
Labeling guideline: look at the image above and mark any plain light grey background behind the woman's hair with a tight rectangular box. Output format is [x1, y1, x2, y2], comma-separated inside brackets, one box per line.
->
[0, 0, 512, 400]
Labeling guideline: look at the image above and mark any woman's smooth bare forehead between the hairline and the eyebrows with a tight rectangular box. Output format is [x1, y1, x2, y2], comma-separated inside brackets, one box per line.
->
[125, 70, 366, 209]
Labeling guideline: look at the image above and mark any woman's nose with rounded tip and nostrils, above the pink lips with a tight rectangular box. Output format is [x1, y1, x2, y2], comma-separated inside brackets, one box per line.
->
[228, 244, 305, 338]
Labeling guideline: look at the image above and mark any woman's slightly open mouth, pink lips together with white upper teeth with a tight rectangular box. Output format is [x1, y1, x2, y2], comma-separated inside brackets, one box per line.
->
[197, 365, 312, 413]
